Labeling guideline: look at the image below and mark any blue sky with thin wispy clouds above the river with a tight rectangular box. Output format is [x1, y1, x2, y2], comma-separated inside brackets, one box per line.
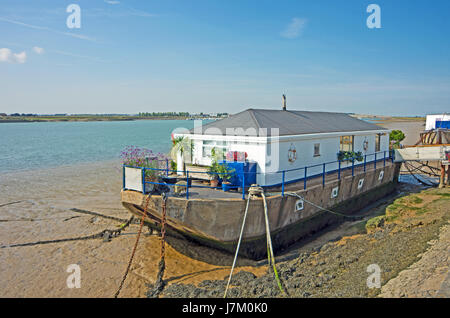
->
[0, 0, 450, 116]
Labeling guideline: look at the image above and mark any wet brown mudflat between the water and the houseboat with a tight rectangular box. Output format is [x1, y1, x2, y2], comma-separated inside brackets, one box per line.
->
[0, 117, 446, 297]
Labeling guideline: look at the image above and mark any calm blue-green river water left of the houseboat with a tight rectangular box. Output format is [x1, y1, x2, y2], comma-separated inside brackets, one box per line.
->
[0, 120, 198, 173]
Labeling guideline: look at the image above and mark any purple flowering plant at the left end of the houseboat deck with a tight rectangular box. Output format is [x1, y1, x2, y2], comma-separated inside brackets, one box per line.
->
[120, 146, 169, 179]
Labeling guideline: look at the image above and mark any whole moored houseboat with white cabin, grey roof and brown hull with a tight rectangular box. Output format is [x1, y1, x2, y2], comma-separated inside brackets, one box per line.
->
[122, 99, 399, 259]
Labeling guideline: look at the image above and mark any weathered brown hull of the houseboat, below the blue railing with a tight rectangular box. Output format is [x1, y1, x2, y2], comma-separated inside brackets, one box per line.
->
[122, 164, 399, 260]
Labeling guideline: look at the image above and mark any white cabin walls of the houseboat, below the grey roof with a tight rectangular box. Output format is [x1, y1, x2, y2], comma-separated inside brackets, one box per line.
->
[174, 110, 389, 186]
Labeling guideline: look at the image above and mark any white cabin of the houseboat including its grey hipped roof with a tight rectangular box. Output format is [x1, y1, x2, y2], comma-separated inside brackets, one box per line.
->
[175, 107, 390, 185]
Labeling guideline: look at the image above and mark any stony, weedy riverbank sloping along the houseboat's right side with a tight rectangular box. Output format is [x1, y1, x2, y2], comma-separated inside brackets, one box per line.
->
[160, 188, 450, 297]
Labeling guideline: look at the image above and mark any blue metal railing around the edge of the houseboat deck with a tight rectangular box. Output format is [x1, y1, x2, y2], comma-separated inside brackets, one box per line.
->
[123, 151, 394, 200]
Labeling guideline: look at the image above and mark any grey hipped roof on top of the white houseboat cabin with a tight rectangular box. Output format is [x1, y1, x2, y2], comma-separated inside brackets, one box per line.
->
[191, 108, 386, 136]
